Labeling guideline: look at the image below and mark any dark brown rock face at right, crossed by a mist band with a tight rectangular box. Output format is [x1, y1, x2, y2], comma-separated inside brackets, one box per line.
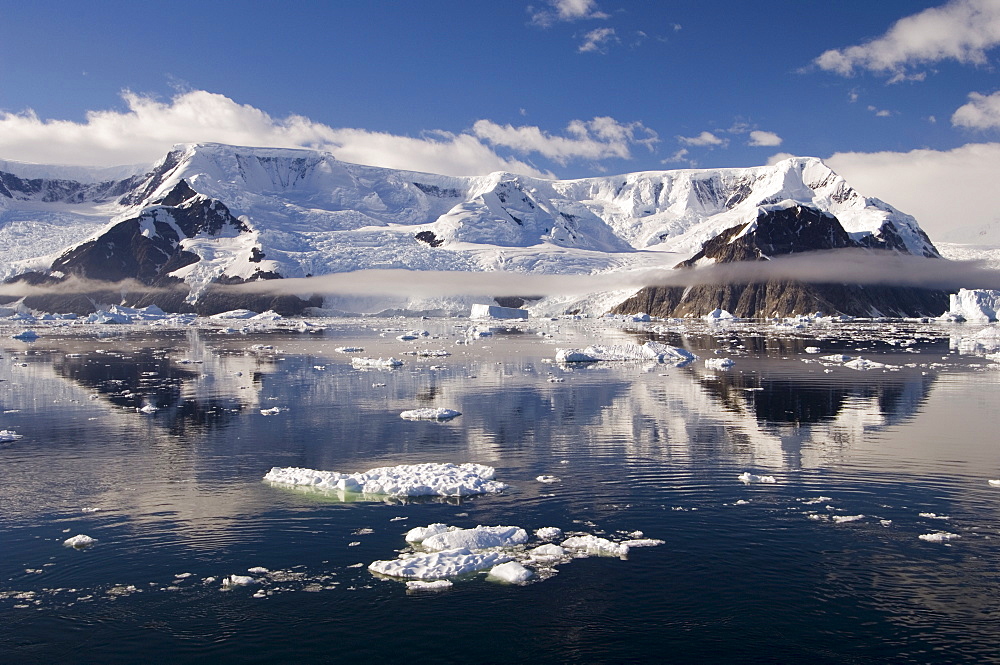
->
[612, 206, 948, 318]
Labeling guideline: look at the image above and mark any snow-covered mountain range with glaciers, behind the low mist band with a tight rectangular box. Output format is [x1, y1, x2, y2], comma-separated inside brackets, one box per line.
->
[0, 144, 939, 312]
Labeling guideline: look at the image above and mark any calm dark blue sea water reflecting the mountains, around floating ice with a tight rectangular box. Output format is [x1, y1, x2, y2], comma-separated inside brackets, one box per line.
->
[0, 320, 1000, 663]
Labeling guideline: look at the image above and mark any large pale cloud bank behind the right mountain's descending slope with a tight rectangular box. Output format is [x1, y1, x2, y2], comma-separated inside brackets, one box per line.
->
[824, 143, 1000, 242]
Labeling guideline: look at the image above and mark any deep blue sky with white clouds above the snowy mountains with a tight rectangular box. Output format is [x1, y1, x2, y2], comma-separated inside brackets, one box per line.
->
[0, 0, 1000, 246]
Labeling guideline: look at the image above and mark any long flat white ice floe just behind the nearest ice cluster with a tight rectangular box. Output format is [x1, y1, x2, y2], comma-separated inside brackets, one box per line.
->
[264, 462, 507, 496]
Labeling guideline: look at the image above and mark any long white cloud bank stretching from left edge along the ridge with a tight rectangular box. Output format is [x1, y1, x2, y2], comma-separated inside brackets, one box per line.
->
[0, 90, 657, 177]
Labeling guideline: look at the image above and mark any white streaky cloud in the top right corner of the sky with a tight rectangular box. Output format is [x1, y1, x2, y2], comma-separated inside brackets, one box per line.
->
[814, 0, 1000, 82]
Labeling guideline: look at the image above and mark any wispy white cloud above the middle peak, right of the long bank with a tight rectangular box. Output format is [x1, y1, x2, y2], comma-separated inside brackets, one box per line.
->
[472, 117, 659, 164]
